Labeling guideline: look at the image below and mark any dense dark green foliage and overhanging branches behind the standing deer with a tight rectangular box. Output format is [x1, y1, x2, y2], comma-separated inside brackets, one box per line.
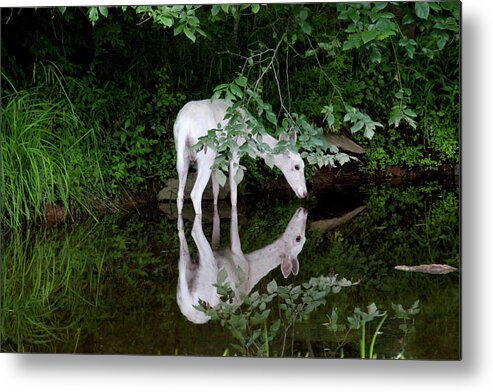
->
[2, 1, 460, 224]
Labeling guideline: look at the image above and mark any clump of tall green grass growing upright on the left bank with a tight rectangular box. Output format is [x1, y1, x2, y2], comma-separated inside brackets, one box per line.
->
[1, 78, 106, 227]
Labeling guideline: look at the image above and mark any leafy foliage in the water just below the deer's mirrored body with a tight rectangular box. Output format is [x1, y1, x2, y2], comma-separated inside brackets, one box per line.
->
[196, 270, 357, 357]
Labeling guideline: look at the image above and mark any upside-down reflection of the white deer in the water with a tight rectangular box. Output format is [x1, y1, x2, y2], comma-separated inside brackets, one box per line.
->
[176, 207, 308, 324]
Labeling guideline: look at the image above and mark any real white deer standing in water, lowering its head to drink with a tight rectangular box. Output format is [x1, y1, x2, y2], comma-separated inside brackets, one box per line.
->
[173, 99, 307, 215]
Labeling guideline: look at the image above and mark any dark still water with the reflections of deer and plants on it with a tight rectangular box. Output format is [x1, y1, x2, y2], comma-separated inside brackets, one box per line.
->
[2, 182, 460, 360]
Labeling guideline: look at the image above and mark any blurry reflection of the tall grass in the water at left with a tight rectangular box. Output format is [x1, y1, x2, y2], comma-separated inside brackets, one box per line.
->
[1, 224, 106, 352]
